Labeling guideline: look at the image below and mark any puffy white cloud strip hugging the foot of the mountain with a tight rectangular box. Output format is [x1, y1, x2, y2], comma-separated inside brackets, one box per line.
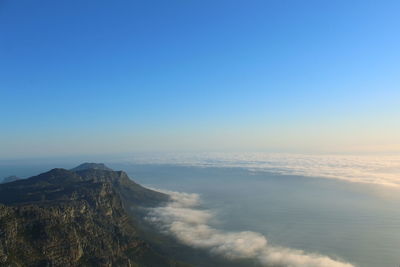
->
[147, 191, 353, 267]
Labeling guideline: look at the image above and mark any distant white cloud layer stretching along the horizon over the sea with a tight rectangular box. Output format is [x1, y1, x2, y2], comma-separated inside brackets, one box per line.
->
[120, 153, 400, 186]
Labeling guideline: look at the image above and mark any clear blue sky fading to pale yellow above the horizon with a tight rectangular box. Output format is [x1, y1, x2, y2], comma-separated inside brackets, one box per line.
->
[0, 0, 400, 159]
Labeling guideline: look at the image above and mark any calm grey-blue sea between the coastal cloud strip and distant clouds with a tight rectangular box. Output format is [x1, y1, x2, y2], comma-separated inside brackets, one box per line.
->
[112, 164, 400, 267]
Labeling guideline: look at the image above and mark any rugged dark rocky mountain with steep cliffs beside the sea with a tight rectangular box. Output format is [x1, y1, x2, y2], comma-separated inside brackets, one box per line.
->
[0, 164, 180, 266]
